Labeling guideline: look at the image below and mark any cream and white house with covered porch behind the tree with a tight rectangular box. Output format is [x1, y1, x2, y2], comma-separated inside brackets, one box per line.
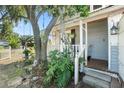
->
[48, 5, 124, 84]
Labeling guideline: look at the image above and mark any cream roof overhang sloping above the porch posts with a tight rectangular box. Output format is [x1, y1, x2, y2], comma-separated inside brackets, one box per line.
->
[53, 5, 124, 30]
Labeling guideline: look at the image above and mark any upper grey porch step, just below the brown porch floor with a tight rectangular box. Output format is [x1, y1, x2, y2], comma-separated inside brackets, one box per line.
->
[84, 68, 111, 82]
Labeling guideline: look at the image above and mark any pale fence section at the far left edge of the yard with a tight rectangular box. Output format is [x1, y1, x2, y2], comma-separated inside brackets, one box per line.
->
[0, 47, 11, 61]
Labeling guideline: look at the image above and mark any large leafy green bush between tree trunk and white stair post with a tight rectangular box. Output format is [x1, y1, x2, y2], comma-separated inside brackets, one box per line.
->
[44, 50, 73, 87]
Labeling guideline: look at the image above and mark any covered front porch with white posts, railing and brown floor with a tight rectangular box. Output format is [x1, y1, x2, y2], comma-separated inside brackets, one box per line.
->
[48, 18, 109, 71]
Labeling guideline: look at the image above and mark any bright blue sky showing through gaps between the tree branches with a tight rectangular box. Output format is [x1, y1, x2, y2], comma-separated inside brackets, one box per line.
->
[13, 12, 52, 35]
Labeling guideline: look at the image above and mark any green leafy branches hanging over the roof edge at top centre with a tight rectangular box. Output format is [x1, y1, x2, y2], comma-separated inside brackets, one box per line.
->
[46, 5, 89, 17]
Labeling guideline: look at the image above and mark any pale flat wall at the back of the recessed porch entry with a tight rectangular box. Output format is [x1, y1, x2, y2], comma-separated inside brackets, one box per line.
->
[88, 20, 108, 60]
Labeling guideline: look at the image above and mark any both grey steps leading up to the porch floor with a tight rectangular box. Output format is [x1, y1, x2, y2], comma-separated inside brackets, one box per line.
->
[83, 67, 113, 88]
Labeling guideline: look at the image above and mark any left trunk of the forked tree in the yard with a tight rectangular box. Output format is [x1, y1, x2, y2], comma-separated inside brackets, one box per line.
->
[25, 5, 41, 65]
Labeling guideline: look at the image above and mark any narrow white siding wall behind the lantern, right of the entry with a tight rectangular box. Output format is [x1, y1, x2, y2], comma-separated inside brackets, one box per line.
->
[108, 14, 121, 72]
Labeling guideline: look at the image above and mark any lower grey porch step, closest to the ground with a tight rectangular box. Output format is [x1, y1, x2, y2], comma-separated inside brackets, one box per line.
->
[83, 75, 110, 88]
